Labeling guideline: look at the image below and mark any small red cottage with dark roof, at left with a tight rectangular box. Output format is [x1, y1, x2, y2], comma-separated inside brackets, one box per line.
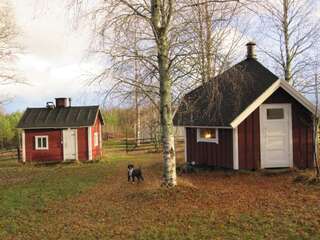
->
[17, 98, 104, 162]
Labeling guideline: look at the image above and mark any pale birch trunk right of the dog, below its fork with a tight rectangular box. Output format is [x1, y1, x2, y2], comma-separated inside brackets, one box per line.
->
[158, 34, 177, 187]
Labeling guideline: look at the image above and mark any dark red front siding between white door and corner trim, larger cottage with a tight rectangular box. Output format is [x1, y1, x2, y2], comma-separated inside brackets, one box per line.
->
[238, 108, 260, 170]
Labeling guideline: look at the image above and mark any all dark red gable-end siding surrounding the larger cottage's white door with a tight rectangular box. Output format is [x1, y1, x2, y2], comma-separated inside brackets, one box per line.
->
[238, 88, 313, 169]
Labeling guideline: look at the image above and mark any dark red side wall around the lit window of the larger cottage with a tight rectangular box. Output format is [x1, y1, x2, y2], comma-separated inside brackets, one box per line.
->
[186, 128, 233, 168]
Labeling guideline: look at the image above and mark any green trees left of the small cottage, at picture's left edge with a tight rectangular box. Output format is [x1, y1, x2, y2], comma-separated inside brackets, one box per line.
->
[0, 112, 22, 149]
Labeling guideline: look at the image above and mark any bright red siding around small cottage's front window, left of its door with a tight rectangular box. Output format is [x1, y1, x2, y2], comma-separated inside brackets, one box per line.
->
[25, 129, 63, 162]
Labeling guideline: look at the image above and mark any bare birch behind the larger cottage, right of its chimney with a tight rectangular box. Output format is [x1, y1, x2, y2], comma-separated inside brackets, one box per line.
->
[260, 0, 319, 87]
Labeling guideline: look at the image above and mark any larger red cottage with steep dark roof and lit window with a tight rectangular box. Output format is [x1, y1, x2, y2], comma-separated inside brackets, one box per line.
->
[174, 43, 315, 170]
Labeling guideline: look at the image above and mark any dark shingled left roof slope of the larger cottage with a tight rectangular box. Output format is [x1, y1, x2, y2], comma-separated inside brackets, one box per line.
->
[173, 59, 278, 127]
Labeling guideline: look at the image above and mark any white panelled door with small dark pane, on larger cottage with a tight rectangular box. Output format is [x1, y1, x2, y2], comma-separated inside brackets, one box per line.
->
[260, 104, 292, 168]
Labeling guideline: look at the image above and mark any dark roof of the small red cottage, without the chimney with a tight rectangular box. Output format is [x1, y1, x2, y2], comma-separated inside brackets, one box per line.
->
[17, 106, 103, 128]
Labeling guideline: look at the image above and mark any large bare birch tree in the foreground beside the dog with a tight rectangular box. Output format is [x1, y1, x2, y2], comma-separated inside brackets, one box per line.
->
[77, 0, 242, 187]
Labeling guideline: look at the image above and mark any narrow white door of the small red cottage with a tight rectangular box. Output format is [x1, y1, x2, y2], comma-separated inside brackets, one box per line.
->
[63, 129, 77, 160]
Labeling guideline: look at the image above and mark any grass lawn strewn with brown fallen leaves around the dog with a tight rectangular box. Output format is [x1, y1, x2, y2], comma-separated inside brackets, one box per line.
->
[0, 143, 320, 240]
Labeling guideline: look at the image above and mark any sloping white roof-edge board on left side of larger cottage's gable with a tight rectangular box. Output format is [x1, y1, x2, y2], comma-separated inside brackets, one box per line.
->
[230, 79, 281, 128]
